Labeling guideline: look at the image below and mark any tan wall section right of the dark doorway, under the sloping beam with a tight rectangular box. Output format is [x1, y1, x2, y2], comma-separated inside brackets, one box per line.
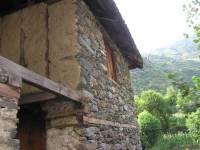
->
[43, 99, 81, 150]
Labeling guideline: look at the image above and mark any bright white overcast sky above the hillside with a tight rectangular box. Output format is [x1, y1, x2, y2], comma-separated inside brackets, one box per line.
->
[115, 0, 192, 52]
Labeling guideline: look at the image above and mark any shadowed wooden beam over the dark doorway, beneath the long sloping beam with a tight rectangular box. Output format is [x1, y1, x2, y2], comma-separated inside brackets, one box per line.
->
[19, 92, 58, 105]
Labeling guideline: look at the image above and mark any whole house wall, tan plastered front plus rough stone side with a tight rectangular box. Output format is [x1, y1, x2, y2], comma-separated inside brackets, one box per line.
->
[0, 0, 140, 150]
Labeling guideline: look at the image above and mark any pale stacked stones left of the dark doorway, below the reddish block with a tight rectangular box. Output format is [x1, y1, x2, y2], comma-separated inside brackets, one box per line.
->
[0, 96, 19, 150]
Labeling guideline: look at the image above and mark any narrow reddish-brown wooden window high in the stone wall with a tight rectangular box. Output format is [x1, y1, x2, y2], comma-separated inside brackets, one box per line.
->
[104, 40, 117, 81]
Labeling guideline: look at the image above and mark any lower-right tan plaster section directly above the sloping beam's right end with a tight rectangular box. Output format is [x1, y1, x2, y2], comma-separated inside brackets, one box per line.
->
[49, 58, 80, 89]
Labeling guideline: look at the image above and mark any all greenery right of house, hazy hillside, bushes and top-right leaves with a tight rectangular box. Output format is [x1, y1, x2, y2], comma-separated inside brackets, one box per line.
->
[131, 0, 200, 150]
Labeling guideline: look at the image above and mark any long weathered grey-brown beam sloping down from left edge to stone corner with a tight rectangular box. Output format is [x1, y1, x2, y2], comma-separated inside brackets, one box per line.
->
[0, 56, 81, 102]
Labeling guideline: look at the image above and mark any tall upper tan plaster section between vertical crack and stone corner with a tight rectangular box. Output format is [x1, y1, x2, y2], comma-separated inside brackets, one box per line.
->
[48, 0, 78, 60]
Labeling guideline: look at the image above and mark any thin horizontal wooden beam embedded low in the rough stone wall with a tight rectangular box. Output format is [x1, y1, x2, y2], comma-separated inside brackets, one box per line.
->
[83, 116, 136, 129]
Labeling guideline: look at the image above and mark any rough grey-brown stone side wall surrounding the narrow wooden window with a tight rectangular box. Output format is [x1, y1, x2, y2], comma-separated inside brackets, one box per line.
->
[76, 1, 140, 150]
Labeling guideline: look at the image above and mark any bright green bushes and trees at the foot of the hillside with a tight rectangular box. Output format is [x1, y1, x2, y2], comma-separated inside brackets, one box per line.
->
[135, 83, 200, 150]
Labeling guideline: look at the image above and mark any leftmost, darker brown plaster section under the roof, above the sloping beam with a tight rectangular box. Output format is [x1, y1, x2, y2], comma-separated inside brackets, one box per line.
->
[1, 11, 21, 63]
